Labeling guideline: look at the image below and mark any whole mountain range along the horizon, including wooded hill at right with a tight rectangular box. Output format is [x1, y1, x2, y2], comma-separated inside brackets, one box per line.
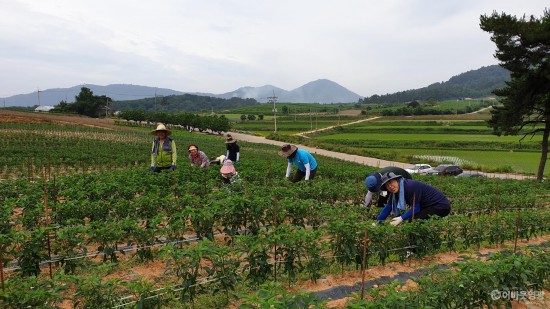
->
[0, 65, 509, 107]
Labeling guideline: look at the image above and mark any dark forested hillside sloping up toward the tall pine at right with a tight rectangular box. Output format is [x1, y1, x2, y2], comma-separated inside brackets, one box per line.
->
[359, 65, 510, 103]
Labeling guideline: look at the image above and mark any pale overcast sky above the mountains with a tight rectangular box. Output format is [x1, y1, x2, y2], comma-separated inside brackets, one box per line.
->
[0, 0, 549, 97]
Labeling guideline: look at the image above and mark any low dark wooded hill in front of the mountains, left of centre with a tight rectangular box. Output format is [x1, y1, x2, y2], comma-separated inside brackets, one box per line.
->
[111, 94, 260, 112]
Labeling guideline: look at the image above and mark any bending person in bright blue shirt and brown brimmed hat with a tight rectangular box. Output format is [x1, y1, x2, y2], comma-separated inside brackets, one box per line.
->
[278, 144, 317, 182]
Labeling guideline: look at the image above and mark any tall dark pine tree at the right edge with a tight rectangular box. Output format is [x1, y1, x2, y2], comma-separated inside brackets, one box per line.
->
[480, 10, 550, 180]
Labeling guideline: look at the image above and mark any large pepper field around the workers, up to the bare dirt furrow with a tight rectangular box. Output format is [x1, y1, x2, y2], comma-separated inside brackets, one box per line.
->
[0, 118, 550, 308]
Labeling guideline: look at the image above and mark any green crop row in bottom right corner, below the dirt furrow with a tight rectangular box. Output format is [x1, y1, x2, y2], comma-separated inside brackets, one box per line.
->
[346, 248, 550, 309]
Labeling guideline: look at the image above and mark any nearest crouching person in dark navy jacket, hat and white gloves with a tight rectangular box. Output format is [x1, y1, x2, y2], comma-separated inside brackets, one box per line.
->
[376, 173, 451, 226]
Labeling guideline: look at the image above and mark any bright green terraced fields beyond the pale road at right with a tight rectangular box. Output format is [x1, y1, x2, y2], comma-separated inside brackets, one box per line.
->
[272, 115, 550, 175]
